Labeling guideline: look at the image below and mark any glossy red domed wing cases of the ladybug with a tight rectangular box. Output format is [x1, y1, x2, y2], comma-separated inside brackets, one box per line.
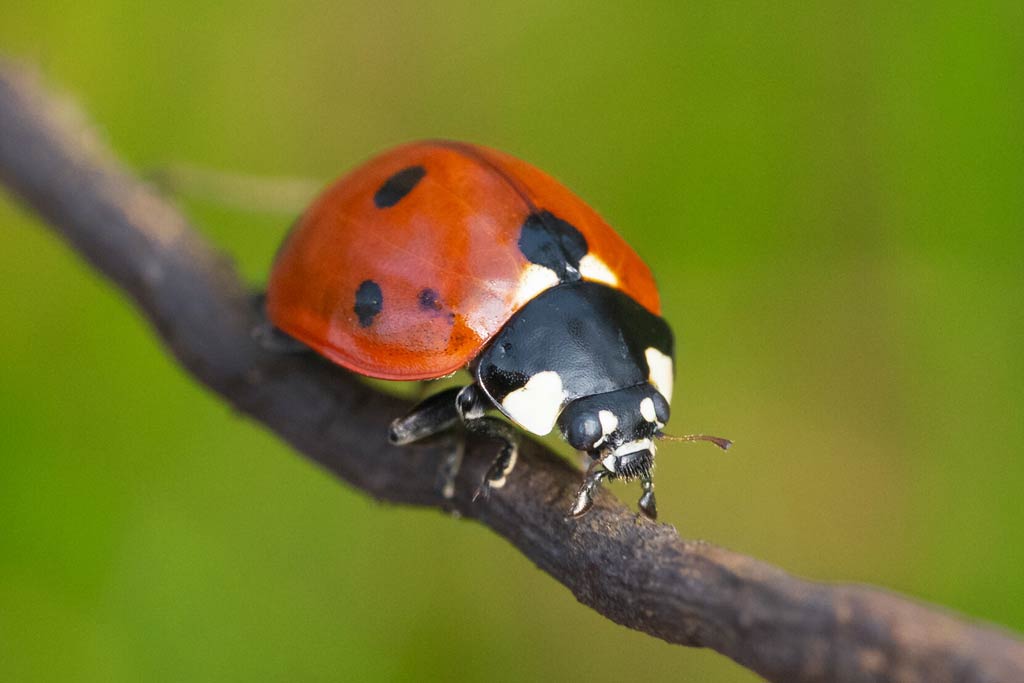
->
[267, 140, 660, 380]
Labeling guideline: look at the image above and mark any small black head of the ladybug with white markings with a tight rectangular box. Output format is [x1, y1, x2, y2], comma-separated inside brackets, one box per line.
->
[558, 383, 669, 479]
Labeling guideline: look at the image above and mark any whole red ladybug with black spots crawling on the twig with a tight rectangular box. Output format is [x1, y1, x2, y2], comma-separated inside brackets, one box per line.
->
[266, 140, 728, 518]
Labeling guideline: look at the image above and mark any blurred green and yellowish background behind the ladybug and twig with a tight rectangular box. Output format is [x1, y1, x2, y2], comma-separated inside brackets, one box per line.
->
[0, 0, 1024, 681]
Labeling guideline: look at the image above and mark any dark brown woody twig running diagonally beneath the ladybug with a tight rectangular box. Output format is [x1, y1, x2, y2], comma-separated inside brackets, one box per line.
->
[0, 62, 1024, 683]
